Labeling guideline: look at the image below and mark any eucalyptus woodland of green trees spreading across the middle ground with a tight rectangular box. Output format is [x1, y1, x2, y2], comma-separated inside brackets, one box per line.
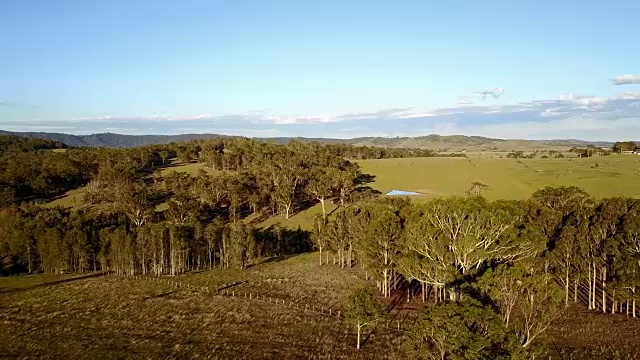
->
[0, 134, 640, 358]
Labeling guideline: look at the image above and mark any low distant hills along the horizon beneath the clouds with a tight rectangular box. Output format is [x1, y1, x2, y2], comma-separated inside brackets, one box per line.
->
[0, 130, 613, 151]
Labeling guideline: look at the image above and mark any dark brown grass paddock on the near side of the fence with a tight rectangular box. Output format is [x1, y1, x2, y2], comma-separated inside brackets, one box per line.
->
[0, 263, 401, 359]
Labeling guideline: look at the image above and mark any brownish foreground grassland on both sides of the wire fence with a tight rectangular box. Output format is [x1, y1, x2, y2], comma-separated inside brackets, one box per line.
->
[0, 253, 640, 359]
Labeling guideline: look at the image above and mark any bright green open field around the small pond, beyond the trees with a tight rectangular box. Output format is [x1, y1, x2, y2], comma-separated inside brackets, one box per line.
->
[358, 155, 640, 199]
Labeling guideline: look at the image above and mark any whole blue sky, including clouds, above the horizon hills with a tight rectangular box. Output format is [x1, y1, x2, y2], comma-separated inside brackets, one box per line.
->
[0, 0, 640, 141]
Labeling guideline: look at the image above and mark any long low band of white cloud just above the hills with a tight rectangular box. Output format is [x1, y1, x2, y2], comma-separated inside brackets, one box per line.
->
[0, 92, 640, 140]
